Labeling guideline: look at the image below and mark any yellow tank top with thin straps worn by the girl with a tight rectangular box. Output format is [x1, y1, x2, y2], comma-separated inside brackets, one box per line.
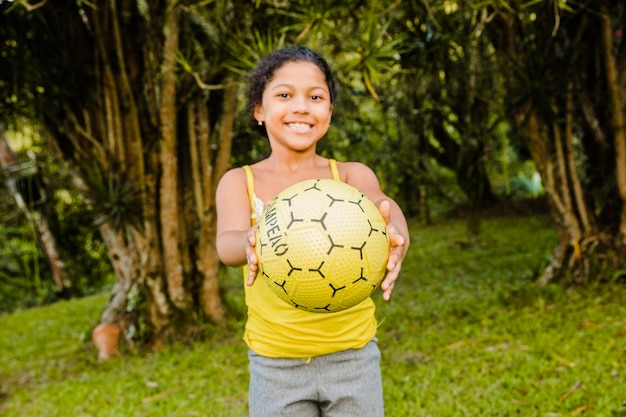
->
[243, 159, 377, 358]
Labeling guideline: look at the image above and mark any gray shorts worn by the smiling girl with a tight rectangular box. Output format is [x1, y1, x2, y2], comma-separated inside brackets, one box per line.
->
[248, 341, 385, 417]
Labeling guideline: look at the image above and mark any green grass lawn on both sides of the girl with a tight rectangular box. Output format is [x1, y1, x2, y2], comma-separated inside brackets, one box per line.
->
[0, 217, 626, 417]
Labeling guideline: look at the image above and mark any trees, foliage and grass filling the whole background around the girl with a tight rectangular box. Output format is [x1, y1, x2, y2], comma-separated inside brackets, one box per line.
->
[0, 4, 626, 416]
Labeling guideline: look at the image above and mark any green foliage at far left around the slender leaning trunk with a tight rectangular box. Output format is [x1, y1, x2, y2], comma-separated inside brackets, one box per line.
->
[0, 129, 113, 312]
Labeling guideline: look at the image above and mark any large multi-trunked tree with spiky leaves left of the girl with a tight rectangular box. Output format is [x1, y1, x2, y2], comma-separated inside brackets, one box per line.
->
[0, 1, 241, 346]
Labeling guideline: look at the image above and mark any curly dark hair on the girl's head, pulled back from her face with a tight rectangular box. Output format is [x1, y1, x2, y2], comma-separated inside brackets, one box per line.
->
[245, 46, 337, 137]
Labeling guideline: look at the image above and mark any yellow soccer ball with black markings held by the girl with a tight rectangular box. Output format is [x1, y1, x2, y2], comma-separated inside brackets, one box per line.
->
[255, 179, 389, 313]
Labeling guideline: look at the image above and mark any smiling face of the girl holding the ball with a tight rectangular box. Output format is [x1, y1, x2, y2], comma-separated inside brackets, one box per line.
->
[254, 61, 333, 152]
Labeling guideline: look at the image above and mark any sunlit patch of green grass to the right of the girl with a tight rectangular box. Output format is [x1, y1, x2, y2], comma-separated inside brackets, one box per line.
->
[379, 218, 626, 416]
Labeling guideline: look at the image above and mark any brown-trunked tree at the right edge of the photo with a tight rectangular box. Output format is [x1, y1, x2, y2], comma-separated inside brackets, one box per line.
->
[485, 0, 626, 284]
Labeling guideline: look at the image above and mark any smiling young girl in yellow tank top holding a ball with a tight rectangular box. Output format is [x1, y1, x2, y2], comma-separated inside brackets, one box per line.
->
[216, 46, 409, 417]
